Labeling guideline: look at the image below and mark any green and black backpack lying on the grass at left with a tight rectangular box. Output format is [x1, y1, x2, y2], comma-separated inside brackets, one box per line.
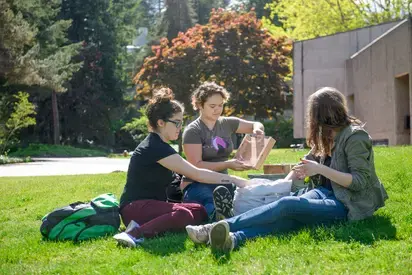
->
[40, 193, 120, 242]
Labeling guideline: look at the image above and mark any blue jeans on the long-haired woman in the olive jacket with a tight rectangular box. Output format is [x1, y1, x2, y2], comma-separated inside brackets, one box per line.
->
[226, 187, 348, 247]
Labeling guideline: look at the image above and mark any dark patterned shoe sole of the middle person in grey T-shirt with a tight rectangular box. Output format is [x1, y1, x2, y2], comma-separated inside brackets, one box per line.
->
[213, 186, 233, 221]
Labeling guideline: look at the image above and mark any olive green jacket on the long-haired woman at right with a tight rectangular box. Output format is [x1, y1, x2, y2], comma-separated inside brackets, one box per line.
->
[310, 125, 388, 220]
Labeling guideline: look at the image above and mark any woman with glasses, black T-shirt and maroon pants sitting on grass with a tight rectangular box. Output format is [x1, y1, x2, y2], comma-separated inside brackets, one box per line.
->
[114, 88, 246, 247]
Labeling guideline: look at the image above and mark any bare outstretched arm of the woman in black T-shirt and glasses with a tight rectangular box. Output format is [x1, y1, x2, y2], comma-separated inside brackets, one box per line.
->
[158, 154, 247, 187]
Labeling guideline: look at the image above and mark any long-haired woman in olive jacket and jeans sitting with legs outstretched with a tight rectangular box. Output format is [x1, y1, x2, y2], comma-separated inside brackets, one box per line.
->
[186, 88, 388, 252]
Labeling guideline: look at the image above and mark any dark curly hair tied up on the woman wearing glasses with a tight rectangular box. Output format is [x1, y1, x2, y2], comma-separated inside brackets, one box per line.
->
[146, 88, 184, 130]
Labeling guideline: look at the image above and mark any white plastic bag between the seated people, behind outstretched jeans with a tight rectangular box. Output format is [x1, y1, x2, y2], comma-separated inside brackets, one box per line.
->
[233, 178, 292, 215]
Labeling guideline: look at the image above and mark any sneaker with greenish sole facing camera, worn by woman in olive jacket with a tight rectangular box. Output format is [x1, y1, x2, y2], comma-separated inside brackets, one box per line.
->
[209, 221, 235, 253]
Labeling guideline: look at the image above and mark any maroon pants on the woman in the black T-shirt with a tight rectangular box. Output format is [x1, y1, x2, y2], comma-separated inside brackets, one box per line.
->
[120, 200, 207, 238]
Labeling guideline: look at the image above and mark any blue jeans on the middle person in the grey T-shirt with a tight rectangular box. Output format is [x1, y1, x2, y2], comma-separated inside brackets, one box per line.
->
[183, 182, 235, 219]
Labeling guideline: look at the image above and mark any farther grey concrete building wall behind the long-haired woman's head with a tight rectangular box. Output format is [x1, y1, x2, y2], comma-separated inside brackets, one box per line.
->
[293, 22, 398, 138]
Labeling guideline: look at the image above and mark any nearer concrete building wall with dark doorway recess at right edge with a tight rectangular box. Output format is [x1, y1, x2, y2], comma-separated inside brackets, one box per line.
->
[346, 20, 411, 145]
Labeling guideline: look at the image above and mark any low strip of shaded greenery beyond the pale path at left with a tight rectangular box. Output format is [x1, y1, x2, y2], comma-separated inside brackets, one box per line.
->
[9, 144, 107, 157]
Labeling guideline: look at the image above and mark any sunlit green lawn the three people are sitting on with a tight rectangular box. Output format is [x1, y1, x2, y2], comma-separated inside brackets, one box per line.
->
[0, 147, 412, 274]
